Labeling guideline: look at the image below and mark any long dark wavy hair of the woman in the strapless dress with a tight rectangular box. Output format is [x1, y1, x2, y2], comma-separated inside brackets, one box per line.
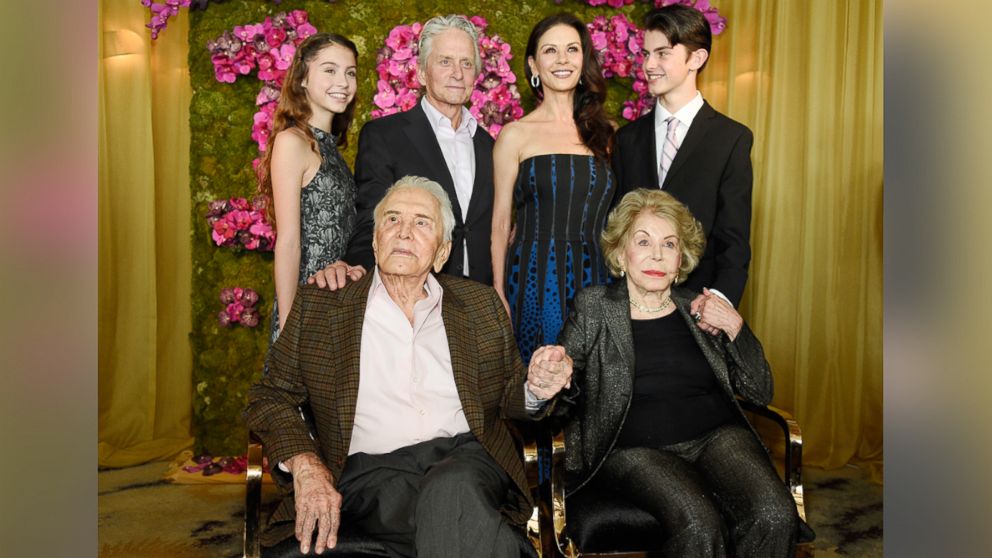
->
[524, 12, 613, 161]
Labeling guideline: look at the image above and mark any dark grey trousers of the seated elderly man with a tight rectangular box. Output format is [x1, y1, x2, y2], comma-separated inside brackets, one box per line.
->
[337, 433, 522, 558]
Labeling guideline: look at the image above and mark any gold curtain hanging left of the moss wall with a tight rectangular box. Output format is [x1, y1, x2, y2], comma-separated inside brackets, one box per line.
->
[98, 0, 193, 467]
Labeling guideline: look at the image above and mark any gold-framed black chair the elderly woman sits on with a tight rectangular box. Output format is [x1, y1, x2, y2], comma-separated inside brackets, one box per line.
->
[523, 401, 815, 558]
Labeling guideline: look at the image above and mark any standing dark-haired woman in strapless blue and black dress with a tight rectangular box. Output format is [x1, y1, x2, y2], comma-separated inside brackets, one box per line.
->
[492, 13, 616, 364]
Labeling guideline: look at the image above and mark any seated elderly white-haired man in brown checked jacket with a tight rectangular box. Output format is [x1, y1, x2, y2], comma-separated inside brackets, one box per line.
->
[246, 176, 571, 557]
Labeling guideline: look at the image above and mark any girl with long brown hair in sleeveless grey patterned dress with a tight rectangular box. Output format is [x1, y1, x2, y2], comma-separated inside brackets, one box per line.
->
[258, 33, 365, 342]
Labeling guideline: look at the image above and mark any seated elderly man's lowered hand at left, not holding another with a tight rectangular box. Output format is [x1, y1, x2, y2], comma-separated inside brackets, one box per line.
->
[286, 452, 341, 554]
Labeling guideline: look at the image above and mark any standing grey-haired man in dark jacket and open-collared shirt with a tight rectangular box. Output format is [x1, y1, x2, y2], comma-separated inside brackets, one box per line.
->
[316, 15, 494, 288]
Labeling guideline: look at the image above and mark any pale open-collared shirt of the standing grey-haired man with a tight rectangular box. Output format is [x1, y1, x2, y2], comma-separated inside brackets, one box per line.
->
[420, 95, 479, 277]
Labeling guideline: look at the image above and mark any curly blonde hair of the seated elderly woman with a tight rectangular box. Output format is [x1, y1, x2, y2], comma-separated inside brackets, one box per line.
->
[599, 188, 706, 284]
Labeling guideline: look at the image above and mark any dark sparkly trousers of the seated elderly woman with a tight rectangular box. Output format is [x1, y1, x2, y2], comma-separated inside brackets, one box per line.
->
[596, 424, 799, 558]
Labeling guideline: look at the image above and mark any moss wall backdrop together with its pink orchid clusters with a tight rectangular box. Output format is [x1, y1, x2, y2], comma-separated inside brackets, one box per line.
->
[182, 0, 727, 455]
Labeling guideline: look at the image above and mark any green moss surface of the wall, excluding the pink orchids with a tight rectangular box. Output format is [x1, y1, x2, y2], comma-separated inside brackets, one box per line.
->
[189, 0, 648, 455]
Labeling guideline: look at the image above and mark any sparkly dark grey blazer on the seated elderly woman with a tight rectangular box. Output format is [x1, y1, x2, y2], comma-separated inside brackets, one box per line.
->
[554, 280, 772, 494]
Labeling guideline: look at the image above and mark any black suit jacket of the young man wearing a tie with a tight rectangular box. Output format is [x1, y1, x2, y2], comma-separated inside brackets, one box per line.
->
[613, 102, 754, 306]
